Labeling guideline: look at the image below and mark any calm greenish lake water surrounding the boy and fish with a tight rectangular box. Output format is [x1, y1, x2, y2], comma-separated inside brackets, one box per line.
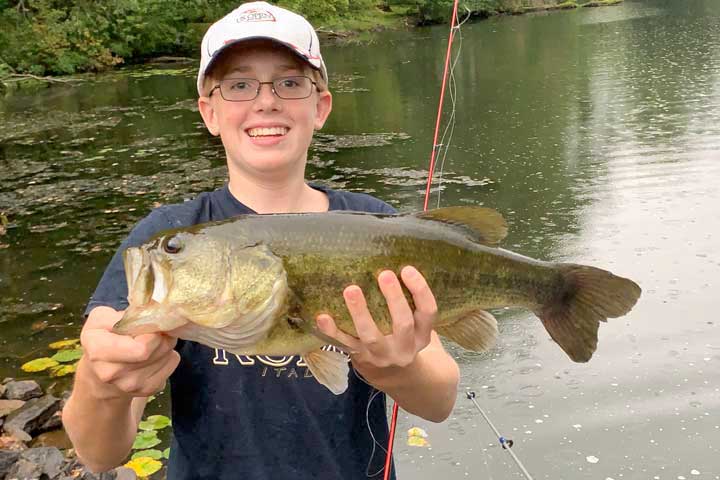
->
[0, 0, 720, 480]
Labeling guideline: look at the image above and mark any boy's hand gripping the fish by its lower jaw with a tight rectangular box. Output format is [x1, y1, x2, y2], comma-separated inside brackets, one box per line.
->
[77, 307, 180, 399]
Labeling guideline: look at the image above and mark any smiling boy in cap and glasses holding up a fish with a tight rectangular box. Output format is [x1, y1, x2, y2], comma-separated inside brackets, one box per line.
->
[63, 2, 458, 480]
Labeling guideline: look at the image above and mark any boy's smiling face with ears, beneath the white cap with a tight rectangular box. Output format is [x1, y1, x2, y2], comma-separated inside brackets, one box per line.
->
[198, 41, 332, 177]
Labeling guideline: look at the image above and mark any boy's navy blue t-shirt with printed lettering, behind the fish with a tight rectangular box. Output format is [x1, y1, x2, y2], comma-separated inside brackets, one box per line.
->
[86, 186, 395, 480]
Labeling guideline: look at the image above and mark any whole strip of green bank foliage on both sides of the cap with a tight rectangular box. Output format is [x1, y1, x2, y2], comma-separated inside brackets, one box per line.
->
[0, 0, 608, 78]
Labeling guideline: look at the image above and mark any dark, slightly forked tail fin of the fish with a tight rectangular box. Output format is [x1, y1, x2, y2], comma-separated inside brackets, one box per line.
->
[535, 264, 641, 362]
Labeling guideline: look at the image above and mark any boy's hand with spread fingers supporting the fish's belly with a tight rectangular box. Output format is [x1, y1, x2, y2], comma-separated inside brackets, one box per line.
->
[317, 267, 437, 380]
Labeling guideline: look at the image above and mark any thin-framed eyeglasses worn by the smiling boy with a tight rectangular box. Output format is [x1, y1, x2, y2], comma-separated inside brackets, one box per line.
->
[208, 76, 317, 102]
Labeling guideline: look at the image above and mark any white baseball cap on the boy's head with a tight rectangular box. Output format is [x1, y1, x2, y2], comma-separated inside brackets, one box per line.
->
[197, 2, 328, 95]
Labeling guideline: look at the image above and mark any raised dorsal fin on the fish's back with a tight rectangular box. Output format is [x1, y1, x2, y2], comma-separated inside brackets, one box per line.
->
[414, 207, 507, 247]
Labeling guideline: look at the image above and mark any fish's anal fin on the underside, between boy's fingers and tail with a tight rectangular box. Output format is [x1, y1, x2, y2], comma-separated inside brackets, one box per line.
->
[435, 309, 498, 352]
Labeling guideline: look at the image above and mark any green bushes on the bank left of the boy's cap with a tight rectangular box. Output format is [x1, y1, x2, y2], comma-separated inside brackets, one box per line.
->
[0, 0, 202, 75]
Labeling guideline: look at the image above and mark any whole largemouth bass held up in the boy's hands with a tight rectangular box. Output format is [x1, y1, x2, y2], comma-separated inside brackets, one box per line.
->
[114, 207, 641, 394]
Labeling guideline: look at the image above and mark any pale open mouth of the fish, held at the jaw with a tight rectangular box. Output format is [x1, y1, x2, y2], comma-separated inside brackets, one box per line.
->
[113, 247, 187, 336]
